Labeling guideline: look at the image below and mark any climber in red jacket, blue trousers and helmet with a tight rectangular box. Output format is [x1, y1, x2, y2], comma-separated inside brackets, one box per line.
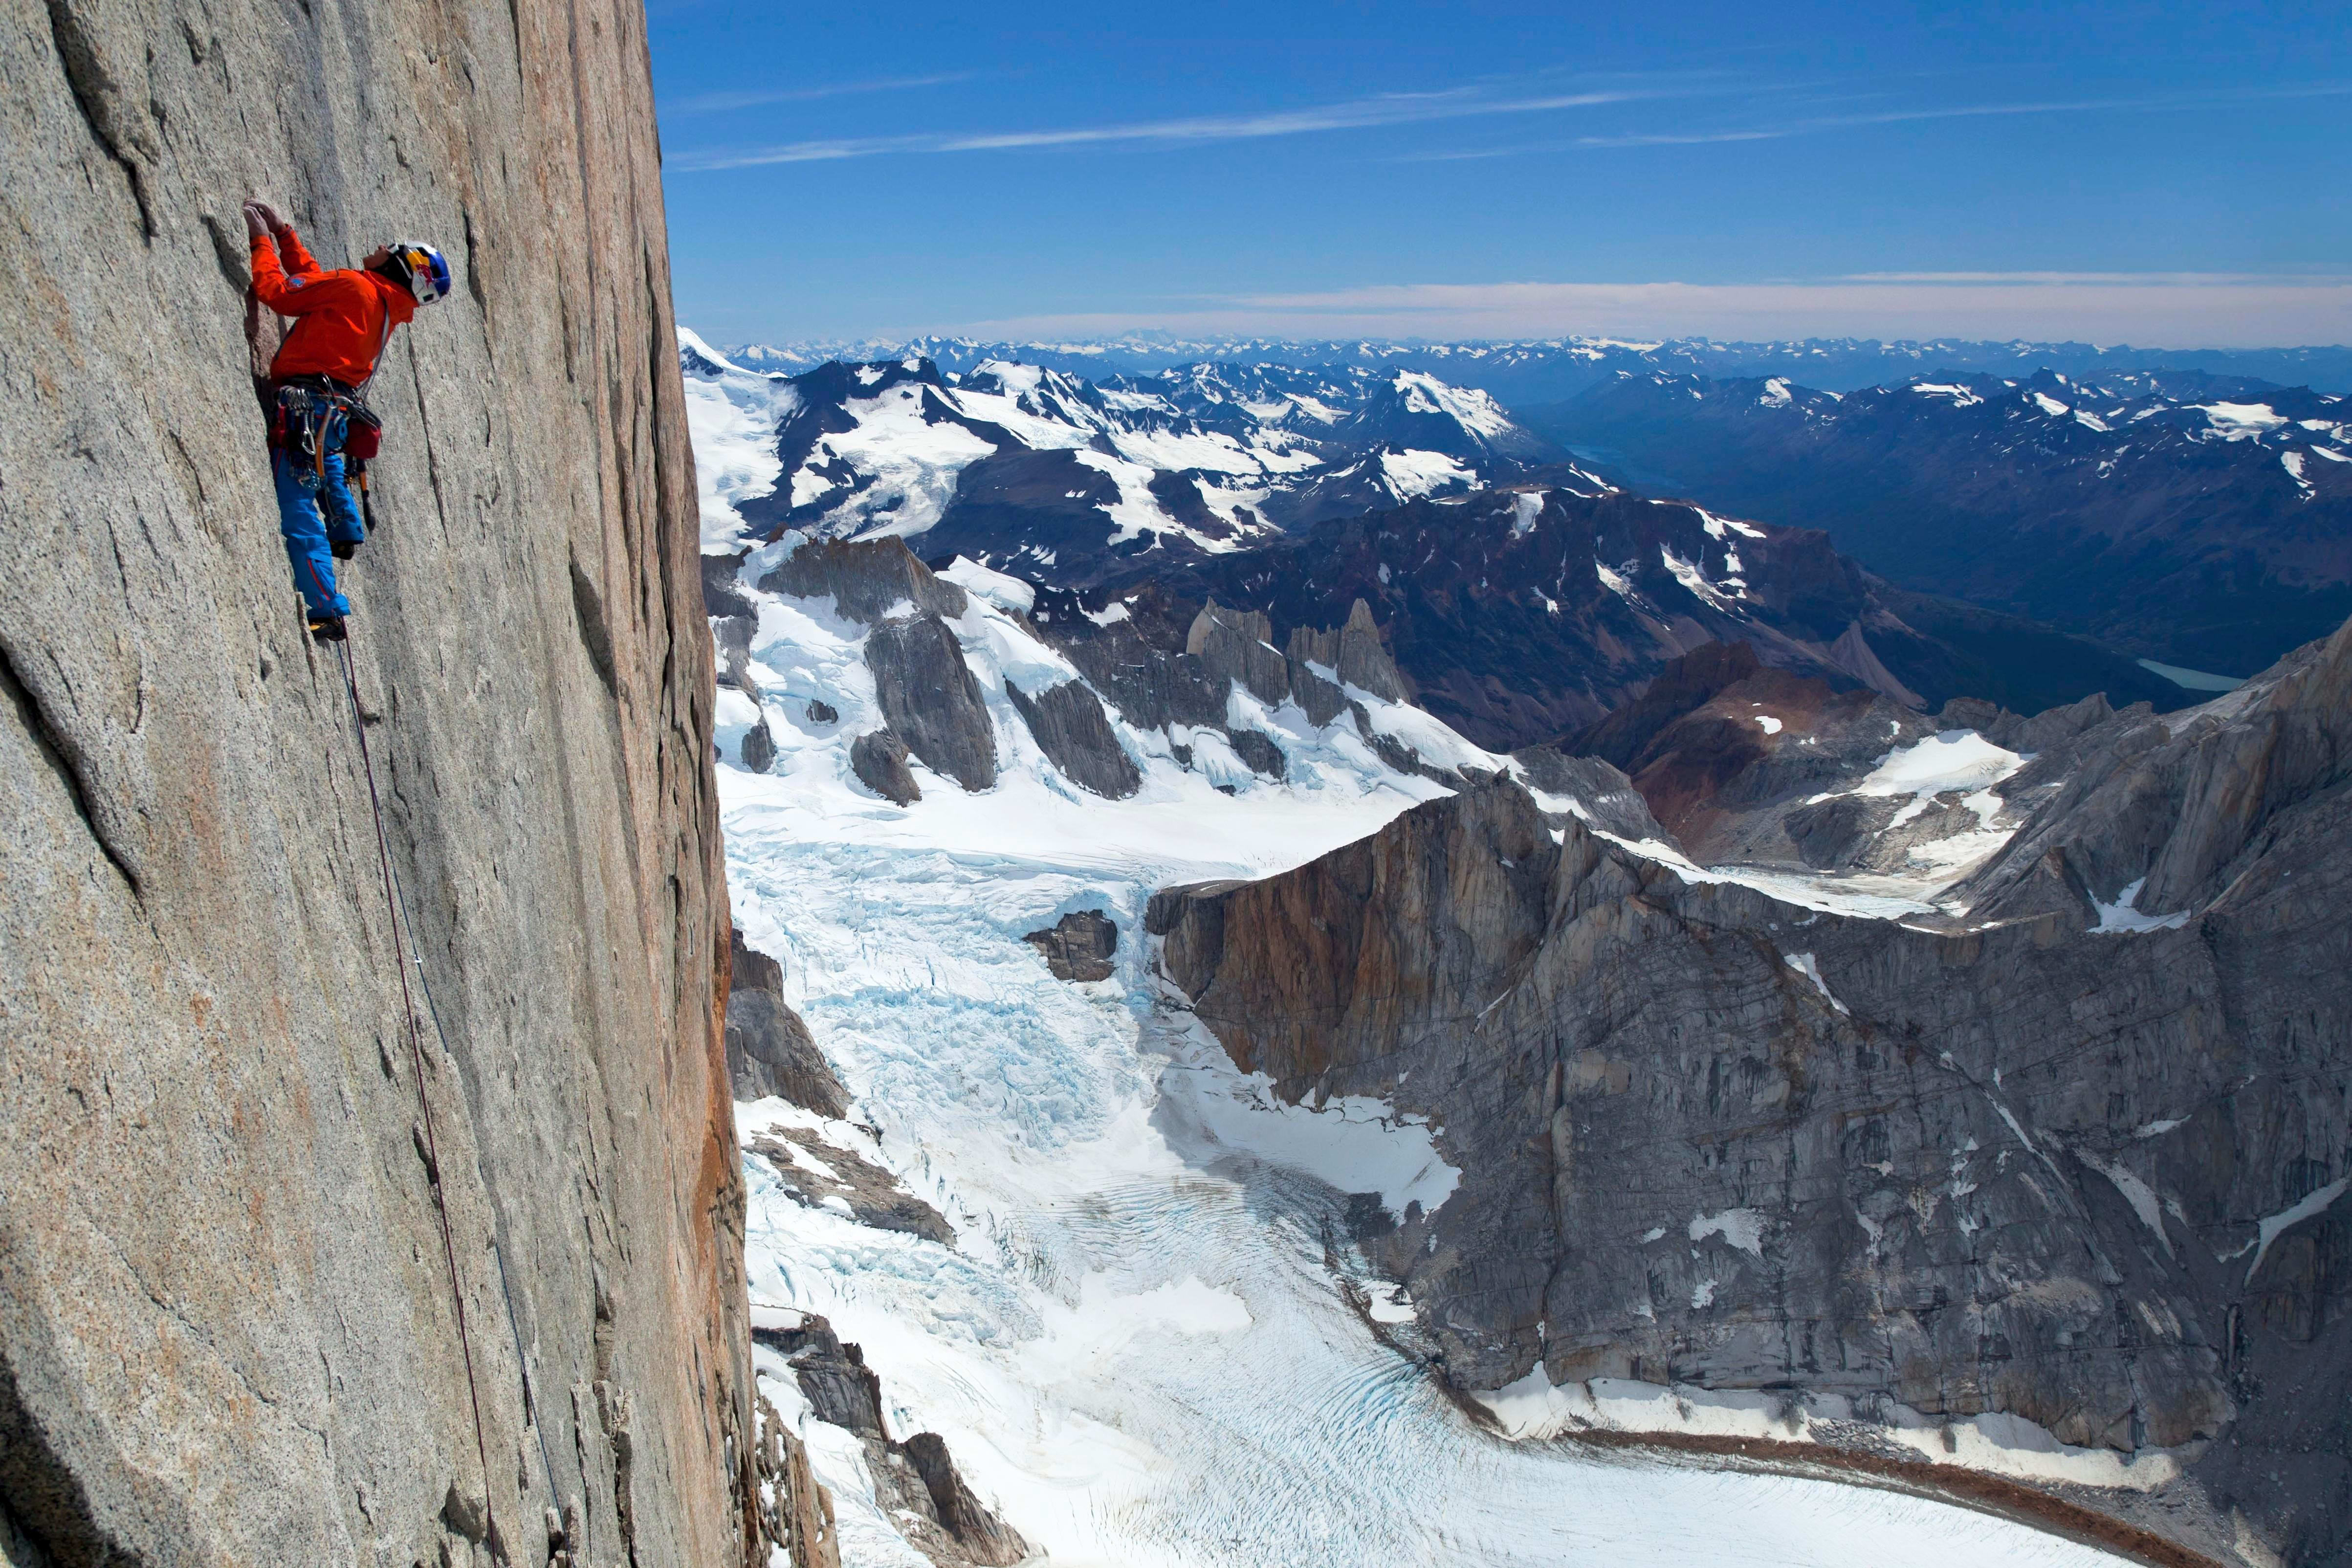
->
[244, 202, 449, 642]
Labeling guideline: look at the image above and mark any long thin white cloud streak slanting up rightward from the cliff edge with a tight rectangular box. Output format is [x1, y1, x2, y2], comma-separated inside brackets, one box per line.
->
[673, 87, 1691, 172]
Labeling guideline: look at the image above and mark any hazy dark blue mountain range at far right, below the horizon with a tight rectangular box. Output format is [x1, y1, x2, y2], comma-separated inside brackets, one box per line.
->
[1524, 369, 2352, 675]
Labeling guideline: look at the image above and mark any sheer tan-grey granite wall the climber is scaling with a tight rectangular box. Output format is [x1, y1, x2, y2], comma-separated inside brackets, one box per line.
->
[0, 0, 750, 1568]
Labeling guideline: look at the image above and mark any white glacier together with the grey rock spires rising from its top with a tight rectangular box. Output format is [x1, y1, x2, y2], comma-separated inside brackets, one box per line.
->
[705, 533, 2182, 1568]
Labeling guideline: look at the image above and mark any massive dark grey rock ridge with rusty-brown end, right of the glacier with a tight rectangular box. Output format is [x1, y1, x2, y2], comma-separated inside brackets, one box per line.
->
[1150, 628, 2352, 1563]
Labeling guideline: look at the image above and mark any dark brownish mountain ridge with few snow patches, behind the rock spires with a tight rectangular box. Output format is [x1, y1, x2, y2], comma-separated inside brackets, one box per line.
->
[1058, 482, 2187, 752]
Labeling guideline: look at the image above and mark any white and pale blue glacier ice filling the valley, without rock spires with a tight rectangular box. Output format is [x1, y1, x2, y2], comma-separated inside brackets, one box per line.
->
[696, 545, 2112, 1568]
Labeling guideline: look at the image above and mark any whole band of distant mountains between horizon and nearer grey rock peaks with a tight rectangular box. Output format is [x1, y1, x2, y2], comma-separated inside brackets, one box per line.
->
[680, 334, 2352, 750]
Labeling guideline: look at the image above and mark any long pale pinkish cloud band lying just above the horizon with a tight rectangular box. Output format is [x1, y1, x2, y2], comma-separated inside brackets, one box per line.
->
[960, 273, 2352, 348]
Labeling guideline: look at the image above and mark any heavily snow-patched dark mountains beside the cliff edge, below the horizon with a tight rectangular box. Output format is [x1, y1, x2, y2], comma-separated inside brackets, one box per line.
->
[680, 331, 1571, 583]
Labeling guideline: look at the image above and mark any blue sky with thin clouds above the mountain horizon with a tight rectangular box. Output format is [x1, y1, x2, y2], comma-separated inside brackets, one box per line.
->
[649, 0, 2352, 346]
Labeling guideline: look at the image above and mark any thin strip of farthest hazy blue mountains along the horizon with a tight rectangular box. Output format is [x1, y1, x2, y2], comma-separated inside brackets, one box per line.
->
[729, 334, 2352, 409]
